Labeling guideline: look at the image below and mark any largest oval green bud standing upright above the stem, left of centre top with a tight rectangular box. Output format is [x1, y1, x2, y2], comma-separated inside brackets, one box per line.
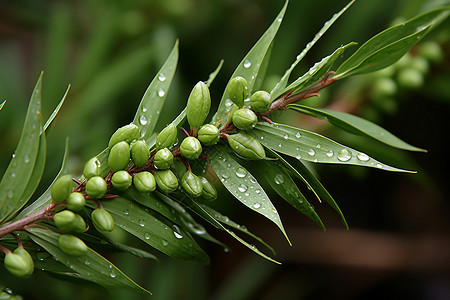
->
[186, 81, 211, 128]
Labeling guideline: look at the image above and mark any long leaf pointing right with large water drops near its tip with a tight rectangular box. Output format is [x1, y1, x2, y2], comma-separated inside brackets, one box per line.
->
[247, 122, 412, 173]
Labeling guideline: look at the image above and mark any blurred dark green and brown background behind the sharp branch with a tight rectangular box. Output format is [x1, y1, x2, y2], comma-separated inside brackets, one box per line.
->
[0, 0, 450, 300]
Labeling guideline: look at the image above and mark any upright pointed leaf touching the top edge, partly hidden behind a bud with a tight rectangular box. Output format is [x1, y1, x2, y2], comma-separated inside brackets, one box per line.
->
[212, 1, 288, 123]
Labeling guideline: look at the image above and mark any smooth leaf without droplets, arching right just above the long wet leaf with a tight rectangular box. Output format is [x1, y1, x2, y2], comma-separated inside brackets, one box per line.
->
[287, 104, 426, 152]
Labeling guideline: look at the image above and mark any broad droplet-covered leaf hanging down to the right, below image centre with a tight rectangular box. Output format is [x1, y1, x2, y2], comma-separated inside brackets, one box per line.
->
[207, 145, 290, 244]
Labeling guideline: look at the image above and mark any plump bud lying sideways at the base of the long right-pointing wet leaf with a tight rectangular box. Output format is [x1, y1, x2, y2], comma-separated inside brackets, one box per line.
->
[228, 132, 266, 160]
